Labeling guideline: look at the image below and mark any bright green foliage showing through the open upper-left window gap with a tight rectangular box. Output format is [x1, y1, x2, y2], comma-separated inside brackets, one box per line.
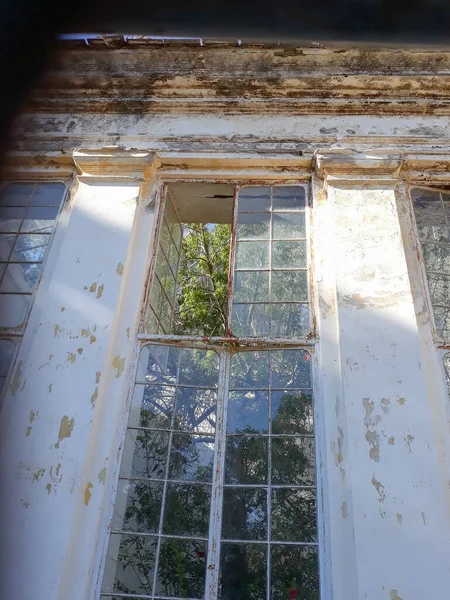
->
[174, 223, 231, 336]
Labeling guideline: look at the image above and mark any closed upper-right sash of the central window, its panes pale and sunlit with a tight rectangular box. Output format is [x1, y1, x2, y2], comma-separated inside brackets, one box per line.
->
[232, 185, 310, 337]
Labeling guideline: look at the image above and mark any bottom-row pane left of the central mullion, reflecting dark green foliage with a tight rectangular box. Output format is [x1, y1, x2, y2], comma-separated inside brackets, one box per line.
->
[155, 539, 208, 598]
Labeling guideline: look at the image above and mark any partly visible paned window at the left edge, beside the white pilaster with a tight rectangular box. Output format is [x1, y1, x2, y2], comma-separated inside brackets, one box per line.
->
[0, 182, 66, 392]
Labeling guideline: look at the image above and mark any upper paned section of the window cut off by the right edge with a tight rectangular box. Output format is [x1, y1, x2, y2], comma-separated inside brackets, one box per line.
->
[411, 188, 450, 341]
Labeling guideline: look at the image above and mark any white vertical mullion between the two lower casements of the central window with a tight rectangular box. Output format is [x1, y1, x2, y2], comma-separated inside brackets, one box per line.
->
[205, 349, 231, 600]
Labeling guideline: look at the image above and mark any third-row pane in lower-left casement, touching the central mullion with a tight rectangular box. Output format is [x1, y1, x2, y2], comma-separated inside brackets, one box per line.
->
[169, 433, 214, 483]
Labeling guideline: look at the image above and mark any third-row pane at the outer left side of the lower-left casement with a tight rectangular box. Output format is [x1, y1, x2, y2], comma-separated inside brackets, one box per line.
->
[120, 429, 169, 479]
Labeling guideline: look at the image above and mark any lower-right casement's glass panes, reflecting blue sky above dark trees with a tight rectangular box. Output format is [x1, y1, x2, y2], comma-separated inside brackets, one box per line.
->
[219, 349, 319, 600]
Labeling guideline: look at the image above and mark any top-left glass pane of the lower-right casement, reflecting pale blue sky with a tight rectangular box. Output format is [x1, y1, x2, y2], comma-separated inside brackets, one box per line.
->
[230, 352, 269, 390]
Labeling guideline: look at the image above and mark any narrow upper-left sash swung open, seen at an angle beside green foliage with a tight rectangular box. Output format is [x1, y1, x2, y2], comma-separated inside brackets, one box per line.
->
[146, 192, 183, 334]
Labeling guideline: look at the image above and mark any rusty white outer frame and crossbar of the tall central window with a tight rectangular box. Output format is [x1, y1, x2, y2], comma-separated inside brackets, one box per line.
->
[97, 169, 331, 600]
